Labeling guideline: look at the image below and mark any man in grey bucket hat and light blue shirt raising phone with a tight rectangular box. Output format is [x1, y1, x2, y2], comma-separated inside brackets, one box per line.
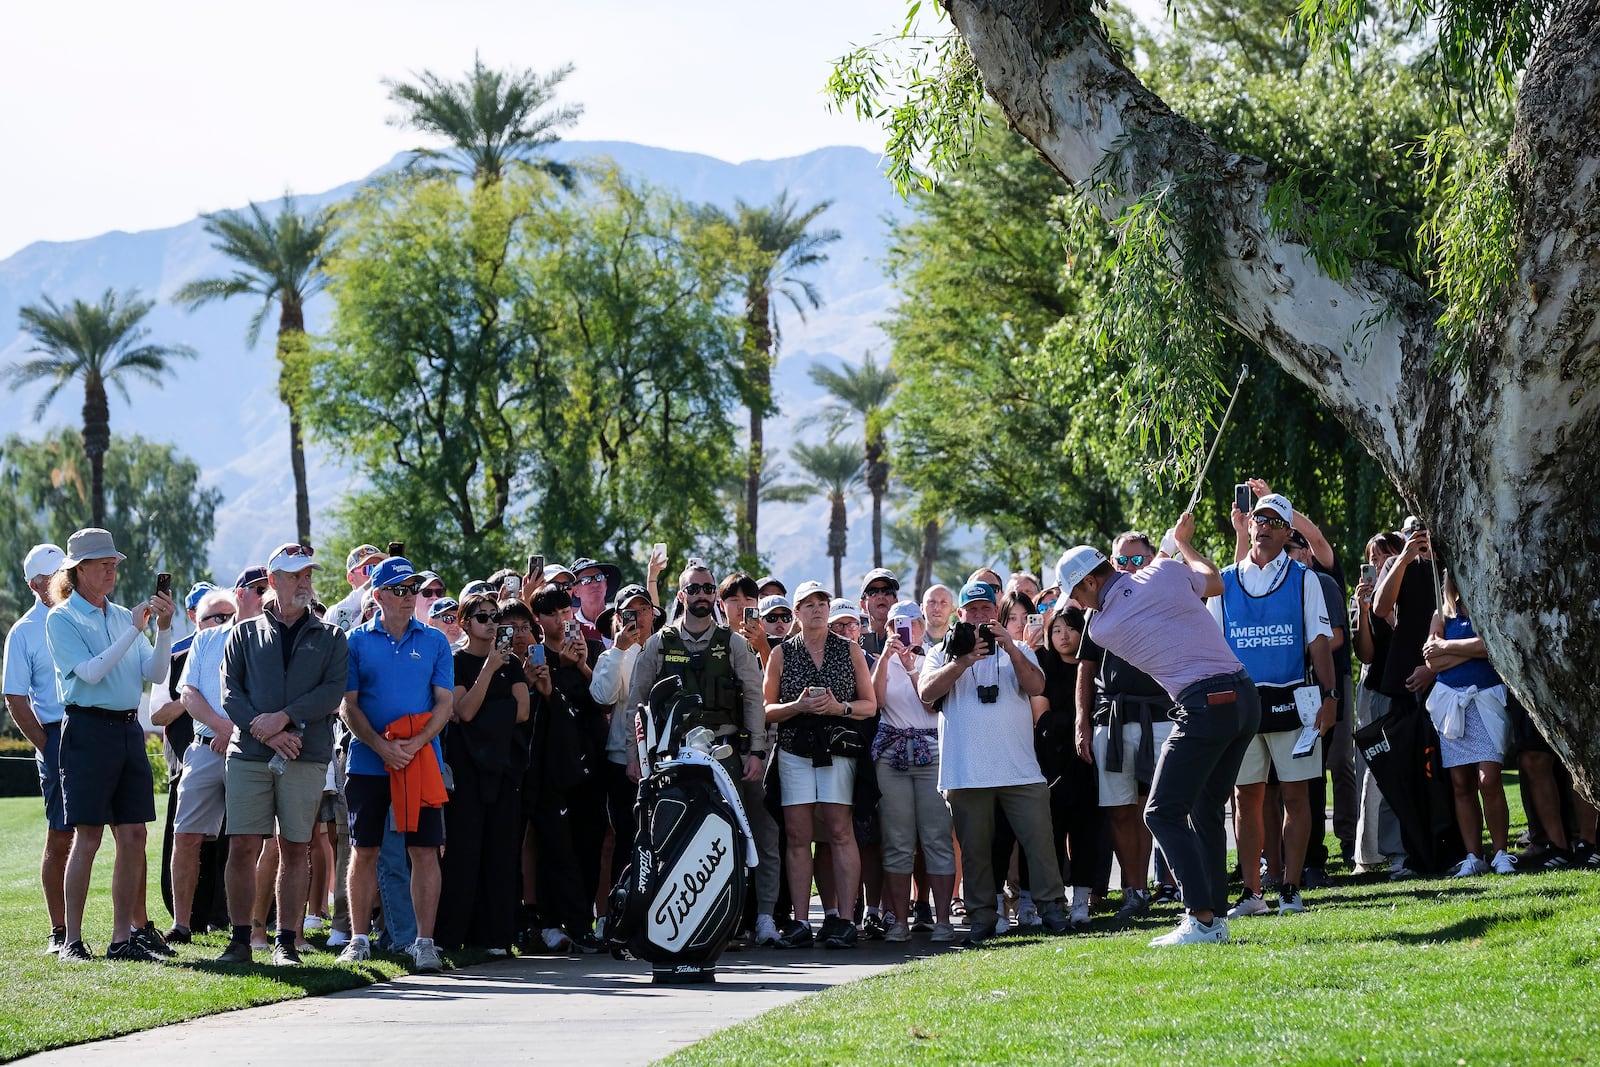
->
[45, 528, 173, 963]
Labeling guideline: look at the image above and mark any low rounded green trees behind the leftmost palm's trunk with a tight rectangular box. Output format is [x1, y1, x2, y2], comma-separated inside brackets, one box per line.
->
[0, 427, 222, 609]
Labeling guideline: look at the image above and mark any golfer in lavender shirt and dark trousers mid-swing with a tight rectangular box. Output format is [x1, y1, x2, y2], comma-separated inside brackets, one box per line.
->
[1056, 512, 1261, 947]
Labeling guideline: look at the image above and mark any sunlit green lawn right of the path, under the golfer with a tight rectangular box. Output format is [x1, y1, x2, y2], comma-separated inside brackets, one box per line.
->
[666, 774, 1600, 1067]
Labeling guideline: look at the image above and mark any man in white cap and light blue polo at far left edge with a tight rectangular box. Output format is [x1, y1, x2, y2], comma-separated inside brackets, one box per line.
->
[5, 544, 72, 953]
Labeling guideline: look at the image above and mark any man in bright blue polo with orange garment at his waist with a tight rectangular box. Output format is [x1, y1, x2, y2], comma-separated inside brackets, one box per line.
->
[339, 557, 456, 971]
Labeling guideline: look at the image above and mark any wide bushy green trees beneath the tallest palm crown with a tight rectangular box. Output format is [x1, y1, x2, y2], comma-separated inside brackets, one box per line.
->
[307, 171, 742, 585]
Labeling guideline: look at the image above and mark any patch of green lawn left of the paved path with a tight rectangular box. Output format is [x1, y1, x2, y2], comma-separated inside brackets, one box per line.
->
[0, 797, 419, 1061]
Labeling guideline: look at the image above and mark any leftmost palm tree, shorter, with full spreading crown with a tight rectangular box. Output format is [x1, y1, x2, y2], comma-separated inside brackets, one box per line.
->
[5, 290, 195, 526]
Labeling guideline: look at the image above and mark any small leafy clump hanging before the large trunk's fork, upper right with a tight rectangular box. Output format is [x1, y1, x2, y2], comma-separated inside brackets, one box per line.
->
[1422, 126, 1517, 373]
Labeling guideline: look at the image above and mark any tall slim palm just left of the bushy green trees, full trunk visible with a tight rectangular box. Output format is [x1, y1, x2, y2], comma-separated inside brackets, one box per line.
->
[174, 195, 333, 544]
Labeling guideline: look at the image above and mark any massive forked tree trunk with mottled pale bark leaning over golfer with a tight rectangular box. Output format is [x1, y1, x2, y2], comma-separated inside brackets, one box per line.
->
[947, 0, 1600, 797]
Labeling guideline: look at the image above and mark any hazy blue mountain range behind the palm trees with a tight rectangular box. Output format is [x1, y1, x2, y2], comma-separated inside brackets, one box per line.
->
[0, 141, 979, 593]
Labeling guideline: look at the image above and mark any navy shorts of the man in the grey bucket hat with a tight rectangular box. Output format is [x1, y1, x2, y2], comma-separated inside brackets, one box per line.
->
[61, 710, 155, 825]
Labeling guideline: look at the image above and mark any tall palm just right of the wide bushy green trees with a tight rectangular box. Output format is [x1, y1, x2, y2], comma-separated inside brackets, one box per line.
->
[733, 190, 838, 557]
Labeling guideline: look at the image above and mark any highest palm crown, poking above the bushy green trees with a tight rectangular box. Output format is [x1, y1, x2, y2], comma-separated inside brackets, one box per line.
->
[384, 54, 584, 187]
